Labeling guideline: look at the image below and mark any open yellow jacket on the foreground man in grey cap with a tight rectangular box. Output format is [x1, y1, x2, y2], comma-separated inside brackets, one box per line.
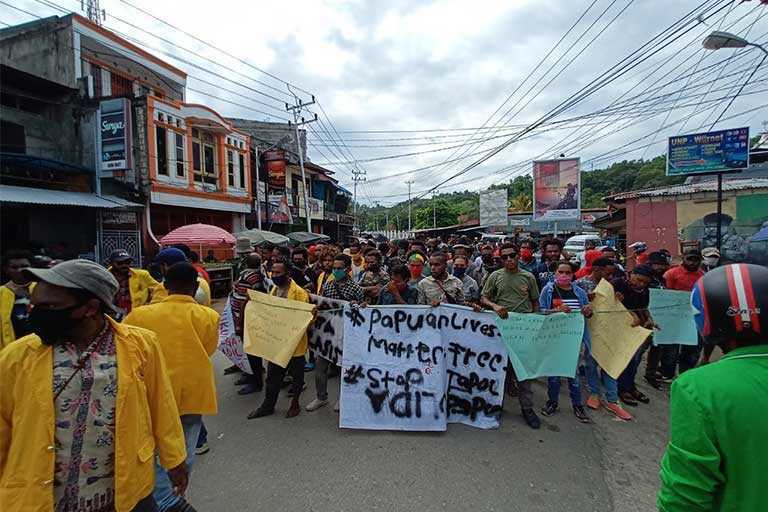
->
[0, 319, 187, 512]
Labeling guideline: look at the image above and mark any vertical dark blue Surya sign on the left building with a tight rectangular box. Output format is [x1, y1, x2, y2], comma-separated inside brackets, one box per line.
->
[99, 98, 133, 171]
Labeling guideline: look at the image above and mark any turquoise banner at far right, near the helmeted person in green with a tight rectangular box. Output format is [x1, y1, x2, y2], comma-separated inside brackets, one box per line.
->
[649, 288, 699, 345]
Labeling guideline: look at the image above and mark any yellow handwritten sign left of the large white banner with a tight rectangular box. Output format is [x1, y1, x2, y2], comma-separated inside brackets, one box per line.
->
[248, 290, 315, 368]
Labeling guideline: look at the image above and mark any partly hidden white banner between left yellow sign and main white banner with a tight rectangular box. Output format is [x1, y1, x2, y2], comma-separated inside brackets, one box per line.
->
[307, 294, 348, 366]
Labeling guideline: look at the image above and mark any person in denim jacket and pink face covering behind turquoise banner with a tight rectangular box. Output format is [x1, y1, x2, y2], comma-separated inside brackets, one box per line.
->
[539, 261, 592, 423]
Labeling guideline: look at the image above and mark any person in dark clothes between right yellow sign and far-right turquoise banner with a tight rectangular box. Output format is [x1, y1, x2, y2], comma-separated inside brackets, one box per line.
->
[611, 265, 657, 406]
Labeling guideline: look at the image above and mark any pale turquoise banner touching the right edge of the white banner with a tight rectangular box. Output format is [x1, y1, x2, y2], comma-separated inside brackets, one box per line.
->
[496, 313, 584, 380]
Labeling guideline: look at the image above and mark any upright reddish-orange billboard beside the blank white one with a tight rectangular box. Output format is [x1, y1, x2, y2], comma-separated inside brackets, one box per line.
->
[533, 158, 581, 221]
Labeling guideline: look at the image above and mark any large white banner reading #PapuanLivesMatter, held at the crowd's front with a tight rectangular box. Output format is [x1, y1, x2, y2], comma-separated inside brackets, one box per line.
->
[339, 305, 507, 431]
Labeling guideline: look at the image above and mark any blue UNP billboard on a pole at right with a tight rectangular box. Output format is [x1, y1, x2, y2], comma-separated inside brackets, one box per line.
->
[667, 128, 749, 176]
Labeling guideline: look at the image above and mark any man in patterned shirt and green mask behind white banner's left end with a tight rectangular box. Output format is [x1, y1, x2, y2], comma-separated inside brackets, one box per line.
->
[306, 254, 365, 412]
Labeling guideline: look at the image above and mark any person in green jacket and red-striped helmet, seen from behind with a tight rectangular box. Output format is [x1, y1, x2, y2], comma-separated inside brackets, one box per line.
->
[657, 264, 768, 512]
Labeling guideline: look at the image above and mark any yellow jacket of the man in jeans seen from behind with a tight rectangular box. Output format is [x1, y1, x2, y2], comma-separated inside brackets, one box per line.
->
[123, 294, 219, 414]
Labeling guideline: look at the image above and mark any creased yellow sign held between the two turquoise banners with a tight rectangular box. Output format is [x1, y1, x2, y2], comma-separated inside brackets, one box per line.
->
[587, 279, 653, 379]
